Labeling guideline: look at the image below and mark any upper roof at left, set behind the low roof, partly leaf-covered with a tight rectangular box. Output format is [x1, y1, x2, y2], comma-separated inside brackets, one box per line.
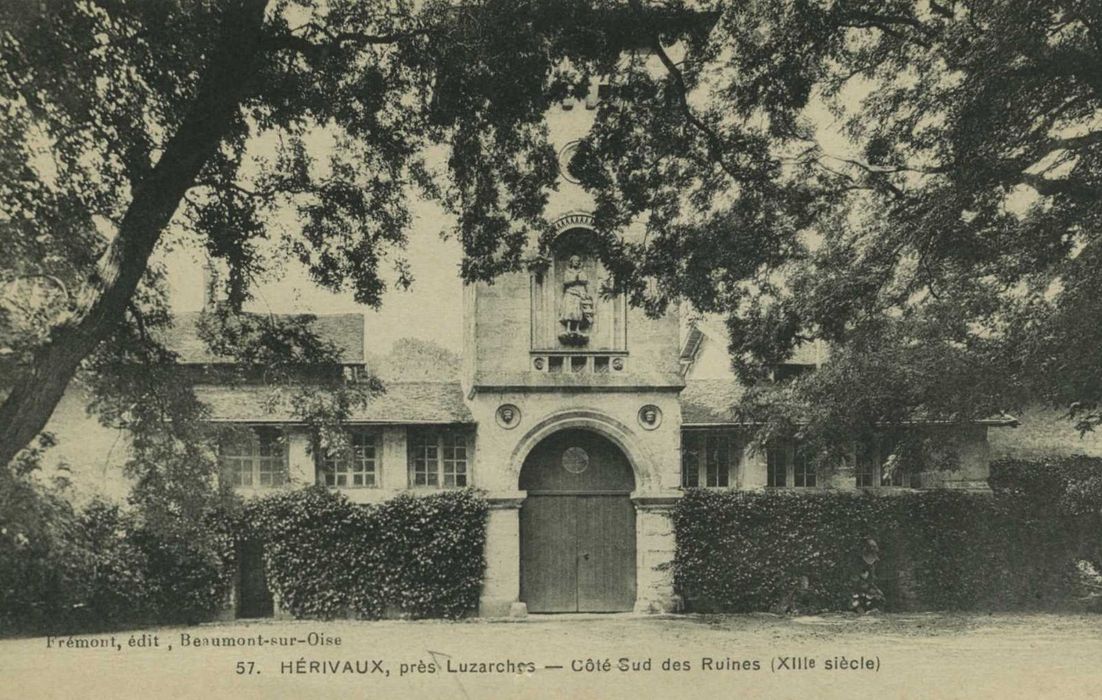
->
[164, 311, 364, 365]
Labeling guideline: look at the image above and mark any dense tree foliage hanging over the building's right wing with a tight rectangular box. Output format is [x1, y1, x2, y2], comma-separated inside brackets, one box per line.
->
[575, 0, 1102, 456]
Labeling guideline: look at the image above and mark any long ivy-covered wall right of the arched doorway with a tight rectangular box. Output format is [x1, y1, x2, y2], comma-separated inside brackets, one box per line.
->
[673, 459, 1102, 612]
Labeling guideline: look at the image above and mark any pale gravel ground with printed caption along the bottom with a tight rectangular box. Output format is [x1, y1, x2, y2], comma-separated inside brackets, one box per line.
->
[0, 614, 1102, 700]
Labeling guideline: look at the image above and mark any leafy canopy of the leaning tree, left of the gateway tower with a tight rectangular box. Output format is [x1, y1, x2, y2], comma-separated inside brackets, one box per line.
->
[0, 0, 639, 476]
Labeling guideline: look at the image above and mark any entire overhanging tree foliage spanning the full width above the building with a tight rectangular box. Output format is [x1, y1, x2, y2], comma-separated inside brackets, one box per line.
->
[0, 0, 1102, 482]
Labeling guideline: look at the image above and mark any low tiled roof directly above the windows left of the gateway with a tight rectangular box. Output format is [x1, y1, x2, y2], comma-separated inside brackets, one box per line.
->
[195, 381, 475, 424]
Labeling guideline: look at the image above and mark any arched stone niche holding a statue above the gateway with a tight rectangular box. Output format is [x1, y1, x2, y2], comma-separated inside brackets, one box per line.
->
[531, 228, 627, 353]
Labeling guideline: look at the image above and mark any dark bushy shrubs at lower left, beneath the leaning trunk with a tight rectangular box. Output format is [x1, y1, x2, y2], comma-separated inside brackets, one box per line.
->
[0, 478, 233, 633]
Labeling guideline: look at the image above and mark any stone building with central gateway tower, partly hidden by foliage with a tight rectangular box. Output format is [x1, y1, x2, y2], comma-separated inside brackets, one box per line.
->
[36, 26, 1066, 616]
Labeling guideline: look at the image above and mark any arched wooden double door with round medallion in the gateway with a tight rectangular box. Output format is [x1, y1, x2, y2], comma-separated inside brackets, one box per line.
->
[520, 429, 636, 613]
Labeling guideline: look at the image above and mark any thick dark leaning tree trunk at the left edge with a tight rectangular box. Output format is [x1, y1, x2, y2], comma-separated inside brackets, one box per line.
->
[0, 0, 267, 474]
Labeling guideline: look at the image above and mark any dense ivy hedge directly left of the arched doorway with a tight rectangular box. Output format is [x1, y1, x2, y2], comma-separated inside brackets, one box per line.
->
[246, 486, 488, 618]
